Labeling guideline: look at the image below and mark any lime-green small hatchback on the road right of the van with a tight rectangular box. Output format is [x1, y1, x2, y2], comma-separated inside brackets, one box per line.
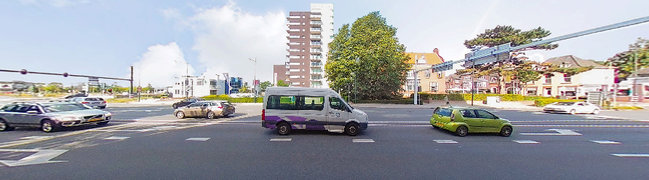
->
[430, 107, 513, 137]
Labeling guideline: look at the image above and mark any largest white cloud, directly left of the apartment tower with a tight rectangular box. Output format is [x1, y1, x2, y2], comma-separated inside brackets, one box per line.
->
[180, 2, 287, 81]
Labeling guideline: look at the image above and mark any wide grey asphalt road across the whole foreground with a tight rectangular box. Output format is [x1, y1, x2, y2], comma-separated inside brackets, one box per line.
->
[0, 107, 649, 179]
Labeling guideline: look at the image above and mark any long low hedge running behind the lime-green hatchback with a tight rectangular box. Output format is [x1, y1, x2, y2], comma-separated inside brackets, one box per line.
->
[419, 93, 526, 101]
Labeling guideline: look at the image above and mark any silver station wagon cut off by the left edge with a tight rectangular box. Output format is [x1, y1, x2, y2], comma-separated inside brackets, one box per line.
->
[0, 102, 112, 132]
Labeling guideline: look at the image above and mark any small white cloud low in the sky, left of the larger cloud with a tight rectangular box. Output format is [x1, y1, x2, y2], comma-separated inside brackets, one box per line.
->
[133, 42, 194, 87]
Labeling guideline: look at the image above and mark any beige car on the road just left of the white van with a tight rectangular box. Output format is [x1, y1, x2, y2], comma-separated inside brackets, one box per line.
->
[174, 101, 235, 119]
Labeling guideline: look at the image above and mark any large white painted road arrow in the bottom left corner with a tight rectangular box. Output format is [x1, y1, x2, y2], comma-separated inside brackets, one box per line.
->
[0, 149, 68, 167]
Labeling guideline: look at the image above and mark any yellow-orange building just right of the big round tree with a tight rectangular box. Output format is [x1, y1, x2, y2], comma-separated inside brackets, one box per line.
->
[403, 48, 446, 96]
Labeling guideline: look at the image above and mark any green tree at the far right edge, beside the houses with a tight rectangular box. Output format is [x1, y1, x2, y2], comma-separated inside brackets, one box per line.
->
[606, 38, 649, 80]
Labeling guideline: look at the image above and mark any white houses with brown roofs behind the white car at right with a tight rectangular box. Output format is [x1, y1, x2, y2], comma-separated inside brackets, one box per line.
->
[523, 55, 615, 98]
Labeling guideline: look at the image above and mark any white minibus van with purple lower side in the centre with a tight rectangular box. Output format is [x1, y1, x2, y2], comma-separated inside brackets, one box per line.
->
[261, 87, 367, 136]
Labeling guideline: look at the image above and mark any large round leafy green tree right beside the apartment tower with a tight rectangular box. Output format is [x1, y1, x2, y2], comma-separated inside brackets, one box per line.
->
[325, 12, 410, 99]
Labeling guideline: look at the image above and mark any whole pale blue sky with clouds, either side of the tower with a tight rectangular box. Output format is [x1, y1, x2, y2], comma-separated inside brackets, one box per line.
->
[0, 0, 649, 86]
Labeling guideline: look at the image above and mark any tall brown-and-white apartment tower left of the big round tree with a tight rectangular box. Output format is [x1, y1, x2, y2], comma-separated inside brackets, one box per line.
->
[273, 3, 334, 88]
